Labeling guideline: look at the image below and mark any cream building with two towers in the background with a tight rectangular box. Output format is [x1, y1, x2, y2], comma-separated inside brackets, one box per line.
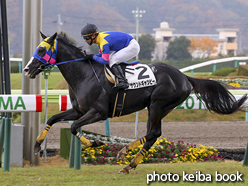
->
[153, 22, 239, 61]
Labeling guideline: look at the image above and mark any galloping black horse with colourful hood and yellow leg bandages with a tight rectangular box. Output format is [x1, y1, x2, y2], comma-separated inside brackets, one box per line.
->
[24, 33, 247, 173]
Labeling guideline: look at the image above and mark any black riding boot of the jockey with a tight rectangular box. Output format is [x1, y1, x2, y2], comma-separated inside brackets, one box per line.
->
[111, 64, 129, 89]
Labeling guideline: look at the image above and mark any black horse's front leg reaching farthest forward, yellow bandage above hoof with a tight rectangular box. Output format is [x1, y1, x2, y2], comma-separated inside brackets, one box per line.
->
[34, 109, 82, 155]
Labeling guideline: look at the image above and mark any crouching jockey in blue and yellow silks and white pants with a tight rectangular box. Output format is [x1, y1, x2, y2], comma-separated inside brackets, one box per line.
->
[81, 23, 140, 89]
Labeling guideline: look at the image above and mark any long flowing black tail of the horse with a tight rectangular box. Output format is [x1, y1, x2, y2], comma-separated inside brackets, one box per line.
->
[187, 76, 247, 114]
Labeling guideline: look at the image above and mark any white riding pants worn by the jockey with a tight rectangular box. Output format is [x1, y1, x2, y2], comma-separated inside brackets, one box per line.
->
[109, 39, 140, 67]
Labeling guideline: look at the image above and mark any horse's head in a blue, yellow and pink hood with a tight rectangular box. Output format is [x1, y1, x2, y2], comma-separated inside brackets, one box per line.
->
[23, 33, 57, 79]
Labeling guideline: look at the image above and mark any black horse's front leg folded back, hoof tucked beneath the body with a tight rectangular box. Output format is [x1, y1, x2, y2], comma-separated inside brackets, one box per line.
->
[71, 108, 107, 147]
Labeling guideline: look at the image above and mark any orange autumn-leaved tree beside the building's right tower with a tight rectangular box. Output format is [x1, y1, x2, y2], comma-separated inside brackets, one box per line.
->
[189, 37, 218, 58]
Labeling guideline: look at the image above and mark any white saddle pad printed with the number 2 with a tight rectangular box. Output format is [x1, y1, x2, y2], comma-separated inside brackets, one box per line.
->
[104, 64, 157, 89]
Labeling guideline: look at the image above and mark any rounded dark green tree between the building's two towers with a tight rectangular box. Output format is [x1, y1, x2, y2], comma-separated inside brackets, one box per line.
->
[166, 36, 192, 60]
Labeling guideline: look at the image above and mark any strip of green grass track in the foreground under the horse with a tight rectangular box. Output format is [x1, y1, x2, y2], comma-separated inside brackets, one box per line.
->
[0, 160, 248, 186]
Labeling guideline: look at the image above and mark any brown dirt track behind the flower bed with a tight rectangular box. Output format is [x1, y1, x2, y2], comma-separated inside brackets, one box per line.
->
[40, 121, 248, 149]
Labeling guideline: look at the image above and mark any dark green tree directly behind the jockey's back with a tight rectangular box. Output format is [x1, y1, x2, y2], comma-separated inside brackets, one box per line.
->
[139, 34, 156, 60]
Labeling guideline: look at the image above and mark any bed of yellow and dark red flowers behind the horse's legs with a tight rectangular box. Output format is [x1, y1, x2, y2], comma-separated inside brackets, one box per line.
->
[82, 135, 224, 165]
